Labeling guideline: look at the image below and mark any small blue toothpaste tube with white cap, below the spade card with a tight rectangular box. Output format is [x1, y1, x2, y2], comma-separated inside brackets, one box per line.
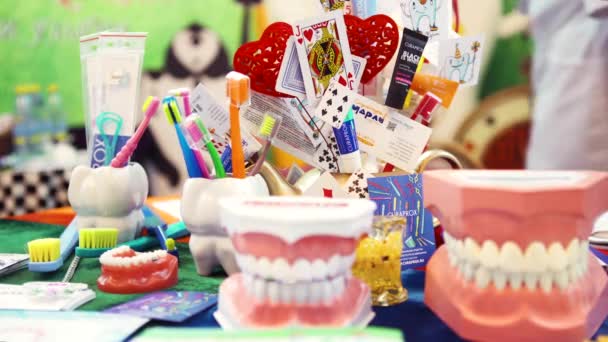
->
[333, 108, 361, 173]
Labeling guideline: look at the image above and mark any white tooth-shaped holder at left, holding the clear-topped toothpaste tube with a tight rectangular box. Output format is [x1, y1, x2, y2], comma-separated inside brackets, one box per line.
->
[68, 163, 148, 243]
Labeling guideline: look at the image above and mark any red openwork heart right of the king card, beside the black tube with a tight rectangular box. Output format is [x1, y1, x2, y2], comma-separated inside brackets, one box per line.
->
[344, 14, 399, 83]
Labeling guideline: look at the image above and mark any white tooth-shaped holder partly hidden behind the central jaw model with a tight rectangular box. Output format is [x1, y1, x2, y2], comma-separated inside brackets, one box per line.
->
[181, 175, 270, 276]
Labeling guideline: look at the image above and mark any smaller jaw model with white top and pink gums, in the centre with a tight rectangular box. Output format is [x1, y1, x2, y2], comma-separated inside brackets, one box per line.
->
[215, 197, 375, 329]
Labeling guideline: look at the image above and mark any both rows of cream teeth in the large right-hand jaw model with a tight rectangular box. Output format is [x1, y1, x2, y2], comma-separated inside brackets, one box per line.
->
[444, 232, 589, 292]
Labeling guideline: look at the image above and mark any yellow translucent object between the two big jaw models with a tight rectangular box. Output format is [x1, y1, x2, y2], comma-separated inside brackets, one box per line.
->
[352, 217, 407, 306]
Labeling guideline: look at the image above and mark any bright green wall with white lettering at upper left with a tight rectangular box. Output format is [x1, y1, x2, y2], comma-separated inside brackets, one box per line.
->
[0, 0, 243, 125]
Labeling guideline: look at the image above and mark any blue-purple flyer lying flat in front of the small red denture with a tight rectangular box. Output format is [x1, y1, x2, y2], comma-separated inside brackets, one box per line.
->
[105, 291, 217, 322]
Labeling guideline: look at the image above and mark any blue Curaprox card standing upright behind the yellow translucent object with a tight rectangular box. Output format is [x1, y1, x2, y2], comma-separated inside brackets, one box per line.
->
[367, 174, 435, 268]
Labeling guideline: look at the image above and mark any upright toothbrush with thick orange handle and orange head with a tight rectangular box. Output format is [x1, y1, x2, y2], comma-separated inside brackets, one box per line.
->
[226, 71, 251, 178]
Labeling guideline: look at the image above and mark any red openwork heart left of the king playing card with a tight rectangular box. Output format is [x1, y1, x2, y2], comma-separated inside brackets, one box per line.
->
[233, 22, 293, 97]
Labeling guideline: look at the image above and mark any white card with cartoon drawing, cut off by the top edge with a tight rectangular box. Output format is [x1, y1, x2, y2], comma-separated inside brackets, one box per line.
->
[400, 0, 452, 43]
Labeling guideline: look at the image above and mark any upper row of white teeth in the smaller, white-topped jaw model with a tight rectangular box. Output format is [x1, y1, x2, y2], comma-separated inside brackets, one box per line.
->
[236, 253, 355, 282]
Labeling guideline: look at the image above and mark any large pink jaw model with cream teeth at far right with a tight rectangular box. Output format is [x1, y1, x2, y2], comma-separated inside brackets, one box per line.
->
[424, 170, 608, 341]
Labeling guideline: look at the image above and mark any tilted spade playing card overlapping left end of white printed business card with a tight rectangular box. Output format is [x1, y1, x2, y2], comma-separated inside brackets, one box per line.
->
[315, 81, 356, 128]
